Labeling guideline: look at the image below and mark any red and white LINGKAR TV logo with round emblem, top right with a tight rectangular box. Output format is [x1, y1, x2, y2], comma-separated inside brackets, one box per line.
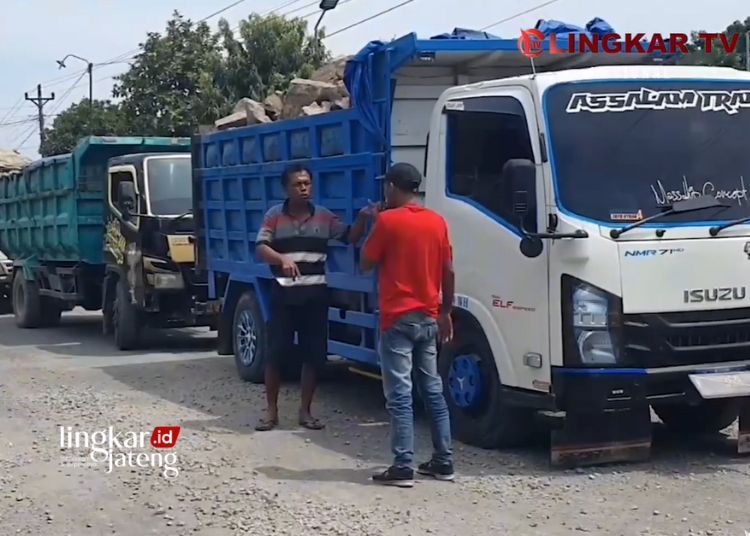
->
[518, 28, 740, 58]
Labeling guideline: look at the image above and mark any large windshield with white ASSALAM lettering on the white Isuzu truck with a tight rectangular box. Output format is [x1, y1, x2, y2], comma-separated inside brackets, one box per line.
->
[545, 80, 750, 225]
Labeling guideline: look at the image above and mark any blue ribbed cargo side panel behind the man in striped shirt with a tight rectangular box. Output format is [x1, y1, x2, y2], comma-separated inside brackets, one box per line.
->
[200, 110, 384, 291]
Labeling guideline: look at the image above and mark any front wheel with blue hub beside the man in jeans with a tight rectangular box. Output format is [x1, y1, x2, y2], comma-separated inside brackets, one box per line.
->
[438, 324, 534, 449]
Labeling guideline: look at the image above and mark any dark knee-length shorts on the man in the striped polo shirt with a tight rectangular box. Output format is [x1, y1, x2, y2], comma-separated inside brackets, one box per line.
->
[269, 296, 328, 367]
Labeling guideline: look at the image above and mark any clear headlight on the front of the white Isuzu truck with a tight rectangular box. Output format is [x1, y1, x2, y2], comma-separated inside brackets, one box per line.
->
[563, 281, 620, 366]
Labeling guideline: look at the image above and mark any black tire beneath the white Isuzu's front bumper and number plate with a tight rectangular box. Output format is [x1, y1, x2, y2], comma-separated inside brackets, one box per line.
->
[653, 399, 740, 434]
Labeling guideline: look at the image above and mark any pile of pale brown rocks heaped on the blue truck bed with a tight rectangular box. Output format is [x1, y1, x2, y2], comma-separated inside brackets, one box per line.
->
[214, 57, 351, 130]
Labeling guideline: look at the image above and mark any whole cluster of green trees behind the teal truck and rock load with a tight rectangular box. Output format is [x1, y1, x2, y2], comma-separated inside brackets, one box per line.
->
[42, 11, 330, 149]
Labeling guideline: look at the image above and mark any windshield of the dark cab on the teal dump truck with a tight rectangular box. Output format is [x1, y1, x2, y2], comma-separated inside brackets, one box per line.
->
[146, 158, 193, 216]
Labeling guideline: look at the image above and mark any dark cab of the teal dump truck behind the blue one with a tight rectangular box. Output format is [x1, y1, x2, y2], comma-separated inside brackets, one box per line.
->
[103, 153, 212, 347]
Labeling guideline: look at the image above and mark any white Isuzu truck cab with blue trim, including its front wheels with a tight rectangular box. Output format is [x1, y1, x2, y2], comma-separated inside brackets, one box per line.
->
[425, 61, 750, 464]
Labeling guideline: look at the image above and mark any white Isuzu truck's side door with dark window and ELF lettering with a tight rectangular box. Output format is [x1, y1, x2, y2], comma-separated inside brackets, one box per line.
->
[426, 87, 550, 392]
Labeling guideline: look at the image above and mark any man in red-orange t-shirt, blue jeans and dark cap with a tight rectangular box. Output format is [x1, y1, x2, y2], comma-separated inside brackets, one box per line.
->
[361, 164, 454, 487]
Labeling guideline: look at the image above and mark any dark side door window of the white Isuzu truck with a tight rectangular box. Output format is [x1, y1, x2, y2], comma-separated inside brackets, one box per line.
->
[446, 97, 536, 232]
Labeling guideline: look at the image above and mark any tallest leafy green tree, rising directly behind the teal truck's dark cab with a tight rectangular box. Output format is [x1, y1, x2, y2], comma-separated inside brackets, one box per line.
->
[112, 11, 230, 136]
